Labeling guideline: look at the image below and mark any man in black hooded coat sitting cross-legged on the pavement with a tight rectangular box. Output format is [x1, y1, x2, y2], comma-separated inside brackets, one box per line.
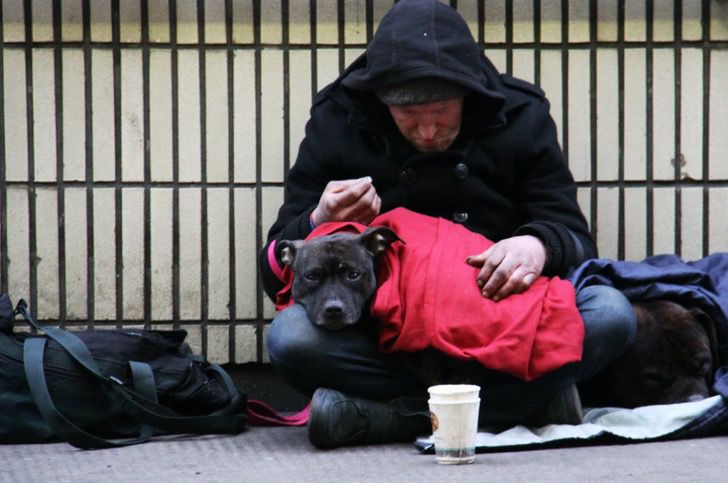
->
[260, 0, 636, 448]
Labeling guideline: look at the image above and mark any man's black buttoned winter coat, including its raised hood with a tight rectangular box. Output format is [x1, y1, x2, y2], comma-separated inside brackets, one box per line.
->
[260, 0, 597, 297]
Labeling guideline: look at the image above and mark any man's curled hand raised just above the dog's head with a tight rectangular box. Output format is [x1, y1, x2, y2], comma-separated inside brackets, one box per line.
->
[312, 176, 382, 225]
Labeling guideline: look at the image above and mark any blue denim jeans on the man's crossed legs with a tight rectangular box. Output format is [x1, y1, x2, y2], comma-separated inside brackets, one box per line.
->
[268, 286, 636, 426]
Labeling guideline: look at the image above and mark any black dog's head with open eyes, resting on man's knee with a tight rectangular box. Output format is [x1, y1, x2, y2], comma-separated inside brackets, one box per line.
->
[276, 226, 401, 330]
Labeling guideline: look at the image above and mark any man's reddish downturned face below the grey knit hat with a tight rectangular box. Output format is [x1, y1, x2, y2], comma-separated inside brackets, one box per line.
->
[388, 97, 463, 153]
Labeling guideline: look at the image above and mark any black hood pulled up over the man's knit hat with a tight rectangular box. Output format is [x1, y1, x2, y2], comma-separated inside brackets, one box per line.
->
[341, 0, 503, 110]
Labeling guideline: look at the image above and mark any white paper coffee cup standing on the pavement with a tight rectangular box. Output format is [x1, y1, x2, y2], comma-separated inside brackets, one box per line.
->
[427, 384, 480, 465]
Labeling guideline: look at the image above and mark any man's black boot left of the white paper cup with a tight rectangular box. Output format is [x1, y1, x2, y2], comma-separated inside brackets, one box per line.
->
[308, 388, 432, 449]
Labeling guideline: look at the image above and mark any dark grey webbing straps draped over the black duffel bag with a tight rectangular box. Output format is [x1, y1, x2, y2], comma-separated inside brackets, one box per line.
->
[16, 299, 247, 449]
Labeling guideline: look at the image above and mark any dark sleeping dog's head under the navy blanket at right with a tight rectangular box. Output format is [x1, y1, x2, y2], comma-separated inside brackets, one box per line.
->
[608, 300, 718, 407]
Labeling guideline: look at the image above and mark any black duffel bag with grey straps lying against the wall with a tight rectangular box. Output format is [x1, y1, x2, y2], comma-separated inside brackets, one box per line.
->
[0, 294, 247, 449]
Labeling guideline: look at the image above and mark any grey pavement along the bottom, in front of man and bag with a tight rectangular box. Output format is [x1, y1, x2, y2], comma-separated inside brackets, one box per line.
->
[0, 427, 728, 483]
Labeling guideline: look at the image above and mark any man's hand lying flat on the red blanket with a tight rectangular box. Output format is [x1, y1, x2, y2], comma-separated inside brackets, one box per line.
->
[466, 235, 546, 302]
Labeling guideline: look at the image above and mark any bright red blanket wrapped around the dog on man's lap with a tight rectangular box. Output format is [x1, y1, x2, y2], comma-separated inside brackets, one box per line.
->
[277, 208, 584, 380]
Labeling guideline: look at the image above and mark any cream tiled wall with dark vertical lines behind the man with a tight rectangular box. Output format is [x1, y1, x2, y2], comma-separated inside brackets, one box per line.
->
[0, 0, 728, 363]
